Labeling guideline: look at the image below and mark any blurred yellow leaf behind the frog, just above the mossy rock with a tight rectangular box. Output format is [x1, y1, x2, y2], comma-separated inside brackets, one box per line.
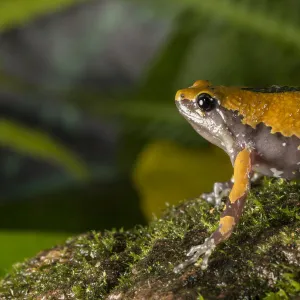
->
[133, 141, 233, 219]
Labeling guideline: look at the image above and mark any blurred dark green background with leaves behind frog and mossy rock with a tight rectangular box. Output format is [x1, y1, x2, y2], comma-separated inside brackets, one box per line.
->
[0, 0, 300, 274]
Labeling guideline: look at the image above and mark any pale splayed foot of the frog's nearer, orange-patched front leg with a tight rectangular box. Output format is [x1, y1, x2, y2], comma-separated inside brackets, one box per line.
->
[174, 237, 216, 273]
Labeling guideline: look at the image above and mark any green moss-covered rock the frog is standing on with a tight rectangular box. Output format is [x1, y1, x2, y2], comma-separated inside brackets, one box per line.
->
[0, 180, 300, 300]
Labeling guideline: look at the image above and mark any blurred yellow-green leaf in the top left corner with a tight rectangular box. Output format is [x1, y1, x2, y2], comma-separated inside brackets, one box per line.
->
[0, 0, 83, 30]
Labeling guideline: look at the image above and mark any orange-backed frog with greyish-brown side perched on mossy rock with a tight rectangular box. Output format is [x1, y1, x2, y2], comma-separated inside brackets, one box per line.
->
[174, 80, 300, 273]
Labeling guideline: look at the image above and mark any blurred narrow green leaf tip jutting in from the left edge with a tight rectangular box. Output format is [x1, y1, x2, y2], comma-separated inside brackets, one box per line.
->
[0, 120, 89, 179]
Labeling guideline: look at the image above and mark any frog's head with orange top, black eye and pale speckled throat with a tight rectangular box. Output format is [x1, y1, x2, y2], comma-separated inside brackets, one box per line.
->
[175, 80, 240, 159]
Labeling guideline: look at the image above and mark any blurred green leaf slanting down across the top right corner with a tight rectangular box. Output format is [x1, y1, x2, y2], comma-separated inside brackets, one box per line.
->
[169, 0, 300, 49]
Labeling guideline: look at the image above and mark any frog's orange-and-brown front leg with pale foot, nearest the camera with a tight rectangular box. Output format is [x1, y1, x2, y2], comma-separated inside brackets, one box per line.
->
[174, 149, 252, 273]
